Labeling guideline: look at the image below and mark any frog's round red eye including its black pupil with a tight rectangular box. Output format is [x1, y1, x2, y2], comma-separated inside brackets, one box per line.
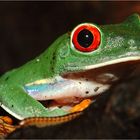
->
[72, 24, 100, 52]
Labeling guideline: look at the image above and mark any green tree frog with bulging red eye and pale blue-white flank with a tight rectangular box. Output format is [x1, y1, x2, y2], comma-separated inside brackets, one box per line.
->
[0, 13, 140, 123]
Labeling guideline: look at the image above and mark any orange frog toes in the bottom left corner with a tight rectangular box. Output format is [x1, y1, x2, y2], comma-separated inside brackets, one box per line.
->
[0, 116, 16, 138]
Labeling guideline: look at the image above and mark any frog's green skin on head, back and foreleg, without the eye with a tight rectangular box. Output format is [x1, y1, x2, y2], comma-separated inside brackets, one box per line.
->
[0, 14, 140, 119]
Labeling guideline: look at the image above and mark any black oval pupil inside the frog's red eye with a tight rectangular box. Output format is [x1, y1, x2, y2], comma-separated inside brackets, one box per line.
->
[77, 29, 94, 48]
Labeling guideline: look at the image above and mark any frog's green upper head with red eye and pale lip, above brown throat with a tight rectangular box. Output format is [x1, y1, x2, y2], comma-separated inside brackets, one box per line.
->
[48, 14, 140, 80]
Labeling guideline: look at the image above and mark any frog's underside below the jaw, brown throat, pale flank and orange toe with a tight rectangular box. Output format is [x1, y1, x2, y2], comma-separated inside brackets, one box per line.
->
[25, 57, 139, 113]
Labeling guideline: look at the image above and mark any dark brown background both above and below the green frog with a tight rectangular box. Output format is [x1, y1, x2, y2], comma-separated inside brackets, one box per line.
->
[0, 1, 140, 139]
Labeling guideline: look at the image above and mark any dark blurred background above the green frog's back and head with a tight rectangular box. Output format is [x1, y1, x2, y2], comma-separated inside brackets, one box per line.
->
[0, 1, 140, 75]
